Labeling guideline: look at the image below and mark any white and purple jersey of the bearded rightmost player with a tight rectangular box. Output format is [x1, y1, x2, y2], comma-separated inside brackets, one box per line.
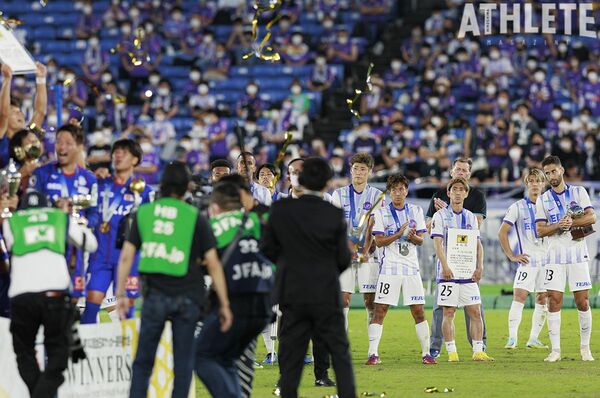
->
[535, 185, 594, 264]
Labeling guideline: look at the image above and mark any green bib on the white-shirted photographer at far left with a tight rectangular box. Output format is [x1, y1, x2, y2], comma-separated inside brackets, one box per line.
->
[7, 208, 67, 256]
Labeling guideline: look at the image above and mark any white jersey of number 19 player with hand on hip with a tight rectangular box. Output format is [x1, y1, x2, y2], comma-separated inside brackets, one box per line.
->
[502, 198, 548, 267]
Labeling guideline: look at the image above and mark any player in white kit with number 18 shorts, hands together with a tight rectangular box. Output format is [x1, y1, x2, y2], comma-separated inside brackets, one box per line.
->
[367, 174, 436, 365]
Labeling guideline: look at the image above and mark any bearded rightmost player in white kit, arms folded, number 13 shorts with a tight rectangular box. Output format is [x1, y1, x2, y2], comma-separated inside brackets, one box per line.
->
[535, 156, 596, 362]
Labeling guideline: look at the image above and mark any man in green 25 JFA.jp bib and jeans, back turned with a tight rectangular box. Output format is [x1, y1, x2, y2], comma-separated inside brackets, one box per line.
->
[117, 162, 232, 398]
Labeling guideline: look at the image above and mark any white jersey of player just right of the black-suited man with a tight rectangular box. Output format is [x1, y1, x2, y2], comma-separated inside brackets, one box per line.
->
[331, 184, 385, 236]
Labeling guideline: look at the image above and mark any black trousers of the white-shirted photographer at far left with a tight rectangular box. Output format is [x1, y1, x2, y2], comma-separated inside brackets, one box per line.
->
[10, 293, 72, 398]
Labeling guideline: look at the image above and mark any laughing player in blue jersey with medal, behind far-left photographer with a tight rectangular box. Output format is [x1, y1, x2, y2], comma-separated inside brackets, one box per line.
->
[29, 124, 99, 298]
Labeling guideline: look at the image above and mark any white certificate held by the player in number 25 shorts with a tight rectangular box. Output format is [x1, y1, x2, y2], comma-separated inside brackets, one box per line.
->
[446, 228, 478, 279]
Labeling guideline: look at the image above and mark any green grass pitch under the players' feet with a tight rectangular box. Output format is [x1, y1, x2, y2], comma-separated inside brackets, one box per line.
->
[196, 309, 600, 398]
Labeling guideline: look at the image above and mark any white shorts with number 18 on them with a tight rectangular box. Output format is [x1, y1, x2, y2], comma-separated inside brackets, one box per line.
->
[375, 274, 425, 306]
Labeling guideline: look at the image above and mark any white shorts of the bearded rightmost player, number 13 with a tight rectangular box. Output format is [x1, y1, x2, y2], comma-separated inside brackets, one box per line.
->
[544, 261, 592, 292]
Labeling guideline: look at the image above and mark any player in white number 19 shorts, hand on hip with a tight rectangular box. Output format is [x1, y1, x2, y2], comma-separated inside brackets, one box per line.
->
[498, 168, 548, 349]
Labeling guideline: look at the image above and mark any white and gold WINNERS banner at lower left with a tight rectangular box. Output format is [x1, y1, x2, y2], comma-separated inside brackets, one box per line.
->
[0, 318, 195, 398]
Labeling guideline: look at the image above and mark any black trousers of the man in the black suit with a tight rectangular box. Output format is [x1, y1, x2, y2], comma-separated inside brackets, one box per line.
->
[279, 304, 356, 398]
